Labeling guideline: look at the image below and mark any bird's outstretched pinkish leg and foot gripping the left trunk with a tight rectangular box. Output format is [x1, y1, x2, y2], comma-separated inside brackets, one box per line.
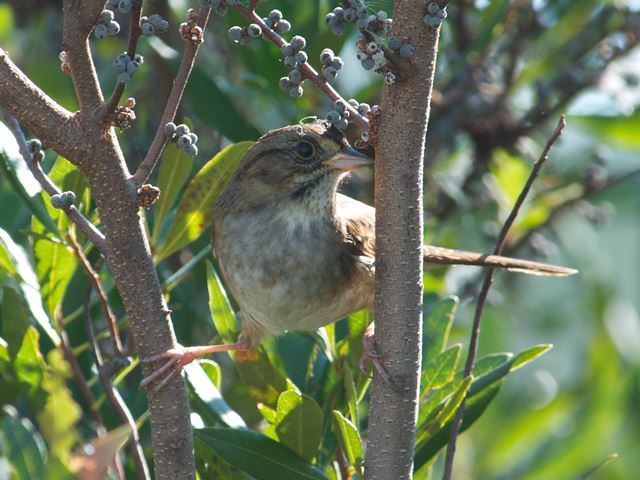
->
[140, 336, 251, 392]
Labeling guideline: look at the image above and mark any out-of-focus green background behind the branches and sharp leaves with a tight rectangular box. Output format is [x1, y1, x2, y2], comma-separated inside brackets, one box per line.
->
[0, 0, 640, 480]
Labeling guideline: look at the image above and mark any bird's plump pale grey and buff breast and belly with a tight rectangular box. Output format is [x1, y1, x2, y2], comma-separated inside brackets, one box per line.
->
[214, 204, 373, 334]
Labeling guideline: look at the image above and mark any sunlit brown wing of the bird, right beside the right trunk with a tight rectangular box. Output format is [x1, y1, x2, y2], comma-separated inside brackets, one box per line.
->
[336, 193, 376, 265]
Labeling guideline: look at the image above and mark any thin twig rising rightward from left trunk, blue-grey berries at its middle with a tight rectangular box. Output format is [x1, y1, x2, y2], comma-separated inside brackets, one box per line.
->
[131, 7, 211, 188]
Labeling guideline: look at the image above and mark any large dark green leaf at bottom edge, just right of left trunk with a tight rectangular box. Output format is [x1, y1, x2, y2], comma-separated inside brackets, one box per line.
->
[194, 428, 327, 480]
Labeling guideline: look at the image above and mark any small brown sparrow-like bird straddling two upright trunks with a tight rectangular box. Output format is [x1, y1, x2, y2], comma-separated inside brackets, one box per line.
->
[142, 120, 576, 389]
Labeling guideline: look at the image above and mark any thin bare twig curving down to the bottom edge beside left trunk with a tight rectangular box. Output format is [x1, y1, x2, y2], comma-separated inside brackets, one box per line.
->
[83, 285, 151, 480]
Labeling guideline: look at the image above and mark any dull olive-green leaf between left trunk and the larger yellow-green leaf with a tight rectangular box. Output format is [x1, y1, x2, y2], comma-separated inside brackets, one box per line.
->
[152, 143, 193, 245]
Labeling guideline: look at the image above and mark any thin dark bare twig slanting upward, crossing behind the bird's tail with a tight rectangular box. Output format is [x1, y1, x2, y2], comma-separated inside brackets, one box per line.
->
[442, 115, 566, 480]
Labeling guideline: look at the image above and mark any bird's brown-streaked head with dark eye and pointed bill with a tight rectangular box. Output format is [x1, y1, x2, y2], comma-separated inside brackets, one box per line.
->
[220, 121, 372, 212]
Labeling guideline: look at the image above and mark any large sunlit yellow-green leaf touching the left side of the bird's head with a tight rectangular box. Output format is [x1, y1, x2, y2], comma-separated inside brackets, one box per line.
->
[156, 142, 253, 262]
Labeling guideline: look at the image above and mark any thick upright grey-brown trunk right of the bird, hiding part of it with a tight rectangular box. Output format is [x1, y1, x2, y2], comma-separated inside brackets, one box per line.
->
[365, 0, 442, 480]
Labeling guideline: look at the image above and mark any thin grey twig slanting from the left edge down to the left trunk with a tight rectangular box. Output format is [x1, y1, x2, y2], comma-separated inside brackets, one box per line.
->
[4, 113, 107, 255]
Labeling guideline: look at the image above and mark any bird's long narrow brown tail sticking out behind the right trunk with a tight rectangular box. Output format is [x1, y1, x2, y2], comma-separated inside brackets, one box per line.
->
[423, 245, 578, 277]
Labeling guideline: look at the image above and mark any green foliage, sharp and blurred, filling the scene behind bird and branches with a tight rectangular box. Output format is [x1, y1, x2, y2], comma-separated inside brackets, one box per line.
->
[0, 0, 640, 479]
